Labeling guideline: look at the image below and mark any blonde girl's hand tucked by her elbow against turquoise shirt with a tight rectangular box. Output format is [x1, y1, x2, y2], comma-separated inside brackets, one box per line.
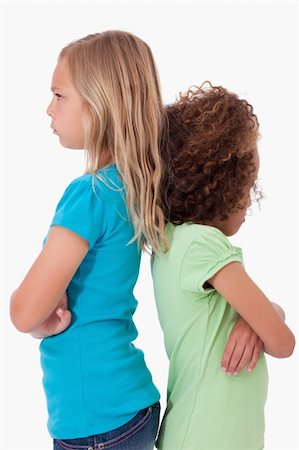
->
[31, 292, 72, 339]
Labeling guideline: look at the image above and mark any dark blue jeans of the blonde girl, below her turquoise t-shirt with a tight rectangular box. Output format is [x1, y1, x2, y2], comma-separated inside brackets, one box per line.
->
[53, 402, 160, 450]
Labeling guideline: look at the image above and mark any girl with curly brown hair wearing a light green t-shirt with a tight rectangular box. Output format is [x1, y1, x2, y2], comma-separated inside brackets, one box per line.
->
[152, 84, 294, 450]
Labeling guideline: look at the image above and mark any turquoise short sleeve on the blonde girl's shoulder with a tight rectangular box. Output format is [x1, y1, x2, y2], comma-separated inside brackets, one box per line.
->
[51, 176, 105, 248]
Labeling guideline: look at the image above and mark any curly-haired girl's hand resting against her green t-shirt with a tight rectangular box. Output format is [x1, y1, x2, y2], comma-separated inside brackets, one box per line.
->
[221, 317, 263, 375]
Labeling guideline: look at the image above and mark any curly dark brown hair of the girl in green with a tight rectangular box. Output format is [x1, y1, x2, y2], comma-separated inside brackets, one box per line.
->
[161, 82, 262, 225]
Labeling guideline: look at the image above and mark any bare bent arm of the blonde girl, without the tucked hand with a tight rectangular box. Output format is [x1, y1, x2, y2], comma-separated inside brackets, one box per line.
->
[10, 226, 89, 337]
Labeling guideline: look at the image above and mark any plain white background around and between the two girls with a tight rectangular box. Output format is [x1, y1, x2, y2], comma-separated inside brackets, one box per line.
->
[1, 1, 298, 450]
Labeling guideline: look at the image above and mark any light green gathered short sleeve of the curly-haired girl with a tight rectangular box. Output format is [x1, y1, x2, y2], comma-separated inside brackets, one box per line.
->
[181, 227, 243, 293]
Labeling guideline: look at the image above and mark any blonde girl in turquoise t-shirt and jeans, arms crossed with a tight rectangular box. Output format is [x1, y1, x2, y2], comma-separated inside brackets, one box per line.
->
[11, 31, 164, 450]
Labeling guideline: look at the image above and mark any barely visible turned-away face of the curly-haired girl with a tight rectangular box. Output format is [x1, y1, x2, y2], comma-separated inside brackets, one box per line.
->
[213, 151, 260, 236]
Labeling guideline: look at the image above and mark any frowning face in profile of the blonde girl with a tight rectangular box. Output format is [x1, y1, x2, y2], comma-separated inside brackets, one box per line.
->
[47, 59, 84, 149]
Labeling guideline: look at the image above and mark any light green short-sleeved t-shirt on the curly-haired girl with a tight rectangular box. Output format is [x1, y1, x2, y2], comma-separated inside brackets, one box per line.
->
[152, 224, 268, 450]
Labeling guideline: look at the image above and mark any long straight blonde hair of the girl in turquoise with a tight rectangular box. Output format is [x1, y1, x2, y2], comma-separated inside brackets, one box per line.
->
[59, 31, 166, 252]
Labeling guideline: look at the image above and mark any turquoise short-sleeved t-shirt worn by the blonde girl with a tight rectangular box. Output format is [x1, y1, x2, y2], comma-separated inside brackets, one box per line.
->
[40, 165, 159, 439]
